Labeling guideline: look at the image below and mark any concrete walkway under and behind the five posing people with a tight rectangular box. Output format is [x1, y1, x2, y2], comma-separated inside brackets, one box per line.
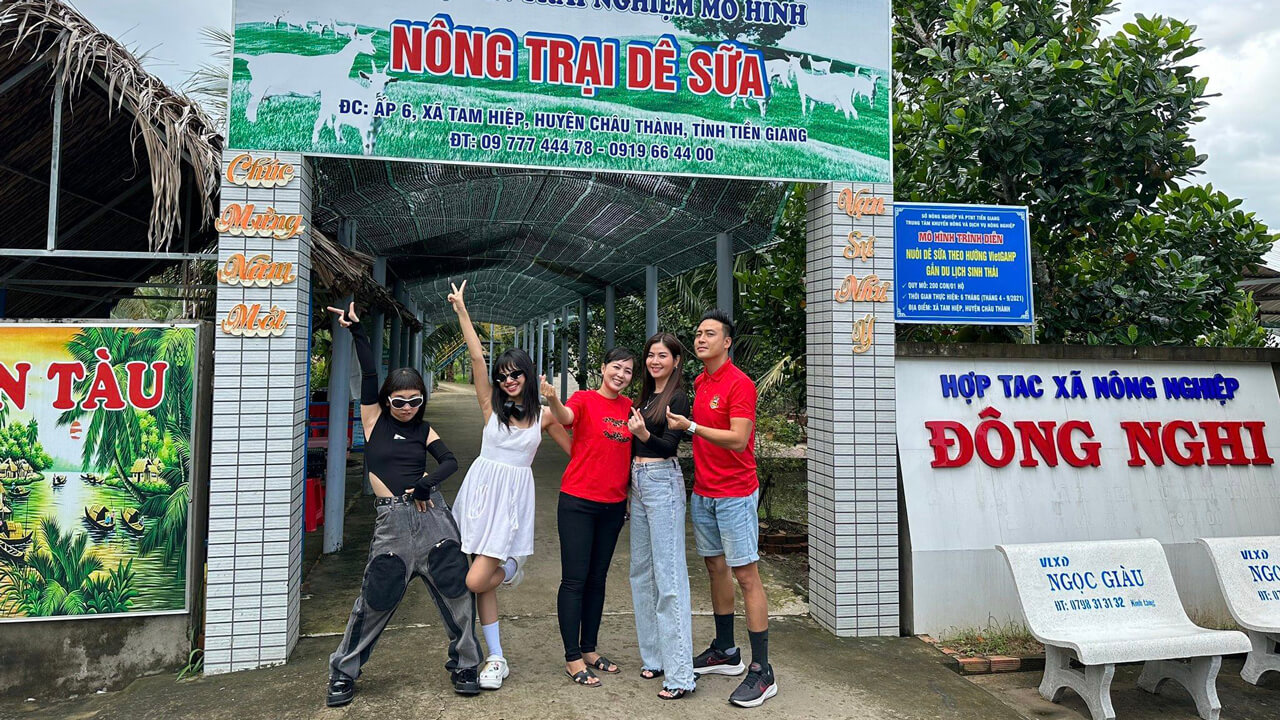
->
[0, 386, 1019, 720]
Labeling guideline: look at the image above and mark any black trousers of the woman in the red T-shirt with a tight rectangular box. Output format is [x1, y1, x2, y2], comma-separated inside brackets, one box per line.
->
[556, 492, 627, 662]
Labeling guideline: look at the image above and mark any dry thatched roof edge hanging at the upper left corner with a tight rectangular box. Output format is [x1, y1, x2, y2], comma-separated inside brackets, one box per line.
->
[0, 0, 221, 250]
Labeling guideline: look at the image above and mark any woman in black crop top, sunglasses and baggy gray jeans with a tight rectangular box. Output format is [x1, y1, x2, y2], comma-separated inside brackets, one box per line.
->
[328, 302, 480, 707]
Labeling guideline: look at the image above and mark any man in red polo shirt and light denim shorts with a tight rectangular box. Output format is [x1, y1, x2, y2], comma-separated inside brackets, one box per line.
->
[667, 310, 778, 707]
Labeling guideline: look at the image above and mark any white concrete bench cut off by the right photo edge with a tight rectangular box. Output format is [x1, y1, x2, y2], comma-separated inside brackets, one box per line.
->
[1199, 536, 1280, 685]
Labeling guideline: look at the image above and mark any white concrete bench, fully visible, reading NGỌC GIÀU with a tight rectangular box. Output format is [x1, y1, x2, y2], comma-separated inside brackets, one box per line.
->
[996, 539, 1249, 720]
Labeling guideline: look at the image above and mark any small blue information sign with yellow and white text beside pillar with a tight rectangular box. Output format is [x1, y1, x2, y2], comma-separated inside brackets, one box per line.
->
[893, 202, 1033, 325]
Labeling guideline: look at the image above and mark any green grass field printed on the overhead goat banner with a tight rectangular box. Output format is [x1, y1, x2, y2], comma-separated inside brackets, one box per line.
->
[229, 23, 890, 182]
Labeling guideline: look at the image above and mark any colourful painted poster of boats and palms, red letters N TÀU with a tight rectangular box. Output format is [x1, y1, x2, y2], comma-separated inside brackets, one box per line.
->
[0, 323, 196, 620]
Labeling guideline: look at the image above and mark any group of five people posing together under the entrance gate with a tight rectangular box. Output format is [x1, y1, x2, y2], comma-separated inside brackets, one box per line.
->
[328, 282, 777, 707]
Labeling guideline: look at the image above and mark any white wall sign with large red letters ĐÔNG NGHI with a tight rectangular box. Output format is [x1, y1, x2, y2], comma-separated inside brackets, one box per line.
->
[897, 357, 1280, 633]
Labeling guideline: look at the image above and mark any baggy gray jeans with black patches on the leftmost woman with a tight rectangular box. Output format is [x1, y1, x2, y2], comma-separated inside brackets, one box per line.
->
[329, 491, 480, 678]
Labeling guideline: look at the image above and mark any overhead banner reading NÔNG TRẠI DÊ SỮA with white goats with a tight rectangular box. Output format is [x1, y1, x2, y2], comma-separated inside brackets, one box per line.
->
[228, 0, 891, 182]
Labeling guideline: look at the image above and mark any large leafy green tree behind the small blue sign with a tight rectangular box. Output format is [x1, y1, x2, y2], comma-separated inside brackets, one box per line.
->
[893, 0, 1275, 343]
